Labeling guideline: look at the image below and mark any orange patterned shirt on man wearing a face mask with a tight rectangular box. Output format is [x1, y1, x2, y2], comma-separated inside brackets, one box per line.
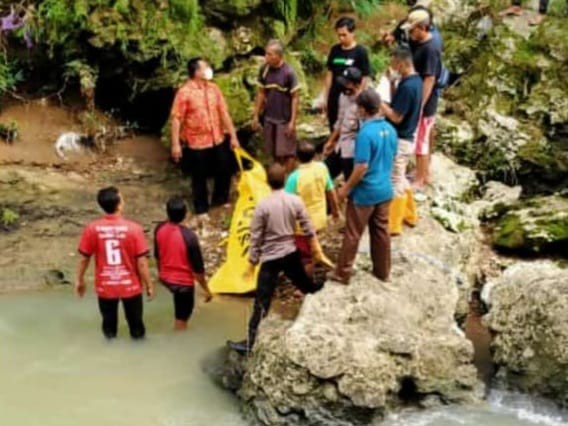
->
[171, 80, 227, 149]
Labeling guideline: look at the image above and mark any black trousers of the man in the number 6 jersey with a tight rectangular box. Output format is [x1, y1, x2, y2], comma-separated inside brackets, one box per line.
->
[99, 294, 146, 339]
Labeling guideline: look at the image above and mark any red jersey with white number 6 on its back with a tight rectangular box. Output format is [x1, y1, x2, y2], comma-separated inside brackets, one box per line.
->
[79, 215, 149, 299]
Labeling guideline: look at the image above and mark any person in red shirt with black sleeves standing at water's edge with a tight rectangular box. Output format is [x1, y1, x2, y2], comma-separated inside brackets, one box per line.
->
[154, 197, 212, 331]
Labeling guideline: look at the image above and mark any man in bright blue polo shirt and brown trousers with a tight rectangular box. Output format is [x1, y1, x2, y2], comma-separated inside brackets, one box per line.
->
[329, 88, 397, 284]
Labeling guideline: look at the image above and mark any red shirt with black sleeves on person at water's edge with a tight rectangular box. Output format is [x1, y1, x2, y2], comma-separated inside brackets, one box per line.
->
[154, 222, 205, 286]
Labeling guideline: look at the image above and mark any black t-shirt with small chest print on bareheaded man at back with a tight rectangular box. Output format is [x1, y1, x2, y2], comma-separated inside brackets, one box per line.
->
[327, 44, 371, 100]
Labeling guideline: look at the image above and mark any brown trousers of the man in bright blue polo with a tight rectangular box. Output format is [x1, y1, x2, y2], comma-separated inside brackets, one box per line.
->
[337, 200, 391, 281]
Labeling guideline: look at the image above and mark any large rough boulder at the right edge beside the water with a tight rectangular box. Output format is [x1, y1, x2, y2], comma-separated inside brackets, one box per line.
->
[484, 261, 568, 405]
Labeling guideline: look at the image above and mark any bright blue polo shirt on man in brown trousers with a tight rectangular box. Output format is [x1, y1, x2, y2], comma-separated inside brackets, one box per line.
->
[349, 118, 398, 206]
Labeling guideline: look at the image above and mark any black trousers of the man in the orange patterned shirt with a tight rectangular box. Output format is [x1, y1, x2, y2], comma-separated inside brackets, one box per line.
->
[182, 140, 234, 214]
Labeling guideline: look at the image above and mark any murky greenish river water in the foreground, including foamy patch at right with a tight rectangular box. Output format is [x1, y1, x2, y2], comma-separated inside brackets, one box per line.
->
[0, 289, 568, 426]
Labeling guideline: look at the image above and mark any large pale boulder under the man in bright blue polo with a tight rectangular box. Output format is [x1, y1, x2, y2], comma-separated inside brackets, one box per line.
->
[235, 255, 483, 426]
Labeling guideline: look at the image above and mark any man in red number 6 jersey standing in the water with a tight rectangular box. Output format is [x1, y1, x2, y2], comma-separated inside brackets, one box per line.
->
[75, 187, 154, 339]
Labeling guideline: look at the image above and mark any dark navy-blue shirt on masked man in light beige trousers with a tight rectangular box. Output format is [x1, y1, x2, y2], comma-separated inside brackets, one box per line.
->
[391, 74, 422, 141]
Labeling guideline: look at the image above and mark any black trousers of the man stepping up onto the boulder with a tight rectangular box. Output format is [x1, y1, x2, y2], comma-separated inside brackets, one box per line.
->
[248, 250, 322, 347]
